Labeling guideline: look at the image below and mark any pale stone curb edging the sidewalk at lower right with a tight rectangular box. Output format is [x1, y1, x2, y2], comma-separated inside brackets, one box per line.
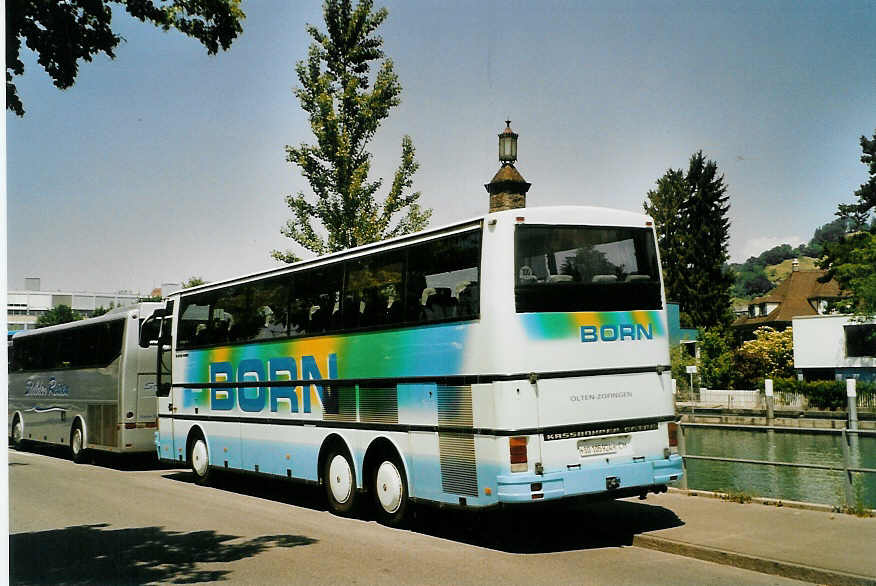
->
[633, 535, 876, 586]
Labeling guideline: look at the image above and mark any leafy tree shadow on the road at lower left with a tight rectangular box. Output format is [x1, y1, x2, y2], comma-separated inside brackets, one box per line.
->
[9, 524, 317, 584]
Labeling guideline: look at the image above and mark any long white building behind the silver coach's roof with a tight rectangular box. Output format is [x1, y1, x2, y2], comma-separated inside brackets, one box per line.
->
[6, 279, 140, 331]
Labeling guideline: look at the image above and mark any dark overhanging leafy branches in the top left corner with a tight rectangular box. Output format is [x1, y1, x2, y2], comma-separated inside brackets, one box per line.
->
[6, 0, 245, 116]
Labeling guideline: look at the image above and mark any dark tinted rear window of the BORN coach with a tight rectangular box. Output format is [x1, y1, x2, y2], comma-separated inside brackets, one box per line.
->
[514, 225, 662, 313]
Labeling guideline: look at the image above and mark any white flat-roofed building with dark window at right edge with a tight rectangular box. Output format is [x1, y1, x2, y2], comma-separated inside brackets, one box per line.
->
[792, 315, 876, 381]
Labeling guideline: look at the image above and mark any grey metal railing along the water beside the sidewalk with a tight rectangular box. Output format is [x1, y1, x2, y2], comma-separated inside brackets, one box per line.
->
[678, 422, 876, 508]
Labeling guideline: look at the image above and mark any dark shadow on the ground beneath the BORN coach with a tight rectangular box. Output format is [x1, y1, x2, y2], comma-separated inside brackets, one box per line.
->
[163, 470, 684, 553]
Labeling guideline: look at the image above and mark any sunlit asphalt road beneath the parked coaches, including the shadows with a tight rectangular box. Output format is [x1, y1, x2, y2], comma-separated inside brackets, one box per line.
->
[9, 450, 798, 584]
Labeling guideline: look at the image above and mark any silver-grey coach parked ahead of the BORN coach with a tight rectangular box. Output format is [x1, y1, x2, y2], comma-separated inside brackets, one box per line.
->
[8, 303, 164, 462]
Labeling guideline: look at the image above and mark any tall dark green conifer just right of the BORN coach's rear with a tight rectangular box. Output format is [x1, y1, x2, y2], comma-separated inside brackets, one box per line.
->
[644, 151, 733, 327]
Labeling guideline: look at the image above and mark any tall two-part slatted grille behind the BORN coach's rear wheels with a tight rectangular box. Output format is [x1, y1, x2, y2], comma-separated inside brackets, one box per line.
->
[438, 386, 478, 497]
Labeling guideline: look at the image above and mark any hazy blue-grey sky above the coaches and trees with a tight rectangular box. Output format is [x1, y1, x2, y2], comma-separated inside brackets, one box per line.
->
[6, 0, 876, 294]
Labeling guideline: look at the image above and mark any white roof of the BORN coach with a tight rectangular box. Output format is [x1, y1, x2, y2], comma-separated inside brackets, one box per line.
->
[173, 205, 652, 299]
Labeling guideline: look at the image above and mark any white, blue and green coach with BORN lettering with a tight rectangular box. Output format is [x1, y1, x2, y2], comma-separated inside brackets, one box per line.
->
[157, 206, 682, 524]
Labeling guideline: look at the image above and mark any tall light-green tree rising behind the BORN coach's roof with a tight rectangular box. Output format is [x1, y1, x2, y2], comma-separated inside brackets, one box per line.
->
[271, 0, 432, 262]
